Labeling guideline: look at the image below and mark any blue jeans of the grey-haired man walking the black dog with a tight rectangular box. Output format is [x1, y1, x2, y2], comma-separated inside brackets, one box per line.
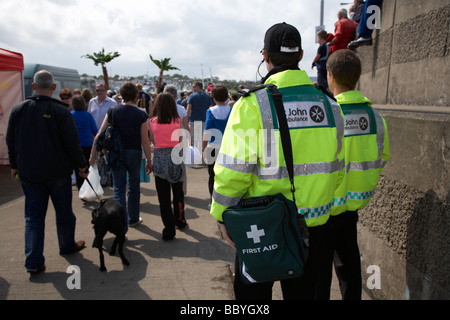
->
[22, 175, 76, 271]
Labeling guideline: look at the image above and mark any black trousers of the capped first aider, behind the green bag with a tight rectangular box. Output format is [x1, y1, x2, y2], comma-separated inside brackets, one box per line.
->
[234, 225, 332, 300]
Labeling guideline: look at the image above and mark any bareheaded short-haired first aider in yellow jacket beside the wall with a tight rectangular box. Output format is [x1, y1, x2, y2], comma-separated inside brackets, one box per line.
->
[327, 49, 389, 300]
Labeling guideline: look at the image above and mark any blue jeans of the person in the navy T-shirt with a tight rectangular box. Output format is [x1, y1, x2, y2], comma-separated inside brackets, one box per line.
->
[111, 150, 142, 232]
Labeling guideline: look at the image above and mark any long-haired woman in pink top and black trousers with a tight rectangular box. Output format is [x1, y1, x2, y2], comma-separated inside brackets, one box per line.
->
[150, 93, 187, 241]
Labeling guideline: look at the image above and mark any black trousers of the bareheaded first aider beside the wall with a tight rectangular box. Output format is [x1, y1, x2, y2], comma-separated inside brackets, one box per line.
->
[327, 211, 362, 300]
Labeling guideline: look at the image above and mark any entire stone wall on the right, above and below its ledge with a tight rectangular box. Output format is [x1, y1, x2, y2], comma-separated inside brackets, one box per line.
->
[357, 0, 450, 299]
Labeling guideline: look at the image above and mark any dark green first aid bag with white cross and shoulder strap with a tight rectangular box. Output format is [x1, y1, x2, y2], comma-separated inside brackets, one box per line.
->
[223, 85, 309, 283]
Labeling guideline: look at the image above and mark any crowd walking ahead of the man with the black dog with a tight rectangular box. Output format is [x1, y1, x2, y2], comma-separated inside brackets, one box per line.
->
[59, 81, 232, 241]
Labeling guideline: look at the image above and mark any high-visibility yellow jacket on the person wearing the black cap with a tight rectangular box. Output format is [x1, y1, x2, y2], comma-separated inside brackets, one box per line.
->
[211, 70, 344, 227]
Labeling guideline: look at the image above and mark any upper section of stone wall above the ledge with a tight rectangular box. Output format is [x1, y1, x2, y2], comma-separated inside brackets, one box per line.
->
[358, 0, 450, 107]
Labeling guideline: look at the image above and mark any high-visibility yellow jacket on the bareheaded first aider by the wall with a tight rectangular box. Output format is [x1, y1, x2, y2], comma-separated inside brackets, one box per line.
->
[331, 91, 389, 215]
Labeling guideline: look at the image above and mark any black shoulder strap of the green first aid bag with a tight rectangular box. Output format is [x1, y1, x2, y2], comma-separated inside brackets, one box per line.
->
[268, 85, 295, 203]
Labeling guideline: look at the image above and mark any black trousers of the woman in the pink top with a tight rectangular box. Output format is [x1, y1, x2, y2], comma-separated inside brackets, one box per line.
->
[155, 177, 186, 240]
